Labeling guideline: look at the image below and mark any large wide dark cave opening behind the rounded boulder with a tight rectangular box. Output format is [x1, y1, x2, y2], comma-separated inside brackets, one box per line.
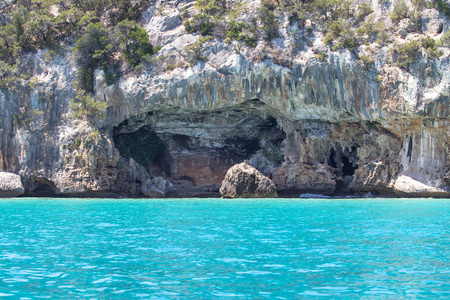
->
[113, 100, 286, 196]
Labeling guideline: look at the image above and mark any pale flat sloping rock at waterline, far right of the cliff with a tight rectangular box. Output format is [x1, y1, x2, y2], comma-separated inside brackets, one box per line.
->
[393, 175, 450, 197]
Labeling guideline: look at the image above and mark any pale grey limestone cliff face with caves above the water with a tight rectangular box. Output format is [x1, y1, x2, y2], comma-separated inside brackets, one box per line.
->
[0, 1, 450, 197]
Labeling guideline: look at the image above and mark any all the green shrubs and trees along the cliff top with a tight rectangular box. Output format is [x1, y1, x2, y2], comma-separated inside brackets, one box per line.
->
[0, 0, 450, 92]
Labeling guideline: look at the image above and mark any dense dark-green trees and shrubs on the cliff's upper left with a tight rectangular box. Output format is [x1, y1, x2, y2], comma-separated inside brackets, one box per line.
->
[0, 0, 157, 91]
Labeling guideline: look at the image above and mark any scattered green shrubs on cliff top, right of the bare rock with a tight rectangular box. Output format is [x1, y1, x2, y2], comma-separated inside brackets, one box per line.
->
[183, 0, 450, 70]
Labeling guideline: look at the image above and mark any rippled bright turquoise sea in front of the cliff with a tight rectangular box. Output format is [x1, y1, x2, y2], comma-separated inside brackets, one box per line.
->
[0, 198, 450, 299]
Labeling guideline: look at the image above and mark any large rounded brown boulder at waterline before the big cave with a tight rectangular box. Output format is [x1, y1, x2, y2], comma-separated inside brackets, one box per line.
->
[220, 163, 278, 198]
